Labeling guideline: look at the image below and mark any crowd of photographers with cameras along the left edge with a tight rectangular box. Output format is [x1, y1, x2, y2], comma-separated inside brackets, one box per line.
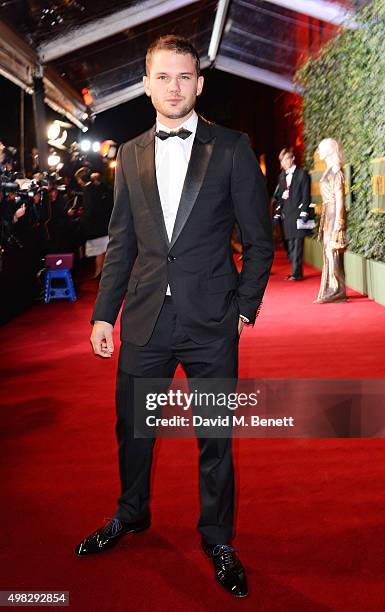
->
[0, 143, 112, 258]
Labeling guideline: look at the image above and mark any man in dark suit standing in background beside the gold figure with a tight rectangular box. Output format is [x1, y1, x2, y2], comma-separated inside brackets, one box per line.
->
[274, 149, 310, 281]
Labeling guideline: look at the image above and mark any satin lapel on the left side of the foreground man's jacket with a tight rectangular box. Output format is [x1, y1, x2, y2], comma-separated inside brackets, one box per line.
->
[136, 130, 170, 248]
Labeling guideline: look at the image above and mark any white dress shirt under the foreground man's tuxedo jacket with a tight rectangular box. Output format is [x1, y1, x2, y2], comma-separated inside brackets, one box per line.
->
[155, 111, 198, 295]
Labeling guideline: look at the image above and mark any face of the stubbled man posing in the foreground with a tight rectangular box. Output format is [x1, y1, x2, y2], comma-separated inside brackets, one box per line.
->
[143, 50, 203, 127]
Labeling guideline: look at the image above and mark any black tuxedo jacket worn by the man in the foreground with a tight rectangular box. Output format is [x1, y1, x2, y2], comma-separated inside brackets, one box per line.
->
[92, 118, 273, 346]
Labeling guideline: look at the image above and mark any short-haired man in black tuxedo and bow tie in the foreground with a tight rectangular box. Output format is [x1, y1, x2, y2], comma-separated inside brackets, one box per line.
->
[76, 36, 273, 596]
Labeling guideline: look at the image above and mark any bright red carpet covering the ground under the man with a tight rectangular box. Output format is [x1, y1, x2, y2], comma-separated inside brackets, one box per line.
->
[0, 251, 385, 612]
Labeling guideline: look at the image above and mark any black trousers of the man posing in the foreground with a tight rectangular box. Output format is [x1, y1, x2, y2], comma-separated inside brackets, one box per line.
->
[116, 298, 238, 544]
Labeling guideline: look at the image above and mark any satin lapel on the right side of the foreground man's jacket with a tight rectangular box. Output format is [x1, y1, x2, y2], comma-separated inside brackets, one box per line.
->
[170, 119, 215, 248]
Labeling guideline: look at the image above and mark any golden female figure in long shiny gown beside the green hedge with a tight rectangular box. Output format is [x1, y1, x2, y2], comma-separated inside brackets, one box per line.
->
[315, 138, 346, 304]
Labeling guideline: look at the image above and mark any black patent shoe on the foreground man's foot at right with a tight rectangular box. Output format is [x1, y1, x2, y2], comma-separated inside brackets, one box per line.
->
[202, 540, 248, 597]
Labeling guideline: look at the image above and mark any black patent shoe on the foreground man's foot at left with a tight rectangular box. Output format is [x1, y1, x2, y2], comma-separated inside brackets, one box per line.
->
[75, 517, 150, 557]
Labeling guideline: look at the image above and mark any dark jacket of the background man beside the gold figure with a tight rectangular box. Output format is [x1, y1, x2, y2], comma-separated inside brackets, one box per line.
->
[274, 166, 310, 240]
